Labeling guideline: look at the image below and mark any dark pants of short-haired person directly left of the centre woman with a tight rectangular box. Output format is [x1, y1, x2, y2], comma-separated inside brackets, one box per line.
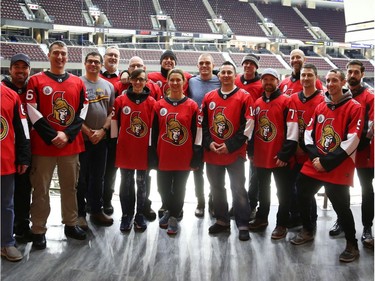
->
[120, 169, 148, 216]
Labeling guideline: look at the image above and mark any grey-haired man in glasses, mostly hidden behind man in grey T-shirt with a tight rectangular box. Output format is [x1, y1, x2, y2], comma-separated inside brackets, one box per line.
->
[100, 46, 120, 215]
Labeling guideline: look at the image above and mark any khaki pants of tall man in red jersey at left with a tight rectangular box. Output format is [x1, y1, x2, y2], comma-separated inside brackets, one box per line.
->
[30, 154, 79, 234]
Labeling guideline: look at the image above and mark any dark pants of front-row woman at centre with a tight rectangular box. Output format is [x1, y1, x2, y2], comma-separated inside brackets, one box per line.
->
[157, 170, 190, 218]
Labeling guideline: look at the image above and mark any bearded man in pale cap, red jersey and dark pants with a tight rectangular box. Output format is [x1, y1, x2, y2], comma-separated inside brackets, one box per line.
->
[249, 68, 298, 239]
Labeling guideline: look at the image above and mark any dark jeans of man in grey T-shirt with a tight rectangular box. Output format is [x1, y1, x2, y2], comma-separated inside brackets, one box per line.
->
[77, 140, 107, 214]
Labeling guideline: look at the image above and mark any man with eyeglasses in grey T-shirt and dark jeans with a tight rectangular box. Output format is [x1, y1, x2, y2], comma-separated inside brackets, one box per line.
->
[77, 52, 115, 230]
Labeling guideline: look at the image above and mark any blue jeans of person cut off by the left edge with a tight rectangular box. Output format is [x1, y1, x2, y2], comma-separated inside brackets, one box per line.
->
[0, 174, 15, 247]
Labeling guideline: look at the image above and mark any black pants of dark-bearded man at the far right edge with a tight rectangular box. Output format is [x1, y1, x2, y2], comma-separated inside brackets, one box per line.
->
[357, 168, 374, 227]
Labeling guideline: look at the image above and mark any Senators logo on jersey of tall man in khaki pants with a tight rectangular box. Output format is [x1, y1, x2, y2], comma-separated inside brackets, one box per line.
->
[47, 92, 75, 126]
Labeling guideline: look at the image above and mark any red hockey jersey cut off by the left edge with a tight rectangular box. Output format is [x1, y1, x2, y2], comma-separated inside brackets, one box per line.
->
[0, 84, 31, 176]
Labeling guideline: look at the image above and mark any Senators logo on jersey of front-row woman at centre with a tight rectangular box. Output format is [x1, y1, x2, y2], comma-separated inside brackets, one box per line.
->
[162, 113, 188, 145]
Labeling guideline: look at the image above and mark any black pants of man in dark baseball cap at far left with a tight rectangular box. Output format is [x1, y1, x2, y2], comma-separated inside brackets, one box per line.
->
[14, 167, 31, 235]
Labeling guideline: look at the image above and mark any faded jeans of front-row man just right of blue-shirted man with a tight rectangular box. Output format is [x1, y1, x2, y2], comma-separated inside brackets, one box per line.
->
[206, 158, 250, 230]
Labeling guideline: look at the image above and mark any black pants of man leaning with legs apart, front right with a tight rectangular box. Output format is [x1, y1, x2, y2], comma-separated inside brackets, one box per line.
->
[297, 174, 356, 242]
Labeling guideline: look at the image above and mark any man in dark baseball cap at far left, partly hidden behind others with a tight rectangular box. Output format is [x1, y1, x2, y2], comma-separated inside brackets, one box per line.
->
[1, 53, 32, 243]
